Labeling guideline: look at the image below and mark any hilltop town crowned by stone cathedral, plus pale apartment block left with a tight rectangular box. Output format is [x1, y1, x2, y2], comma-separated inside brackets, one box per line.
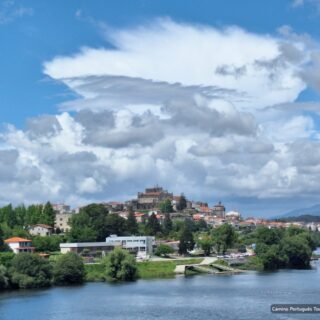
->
[52, 186, 320, 232]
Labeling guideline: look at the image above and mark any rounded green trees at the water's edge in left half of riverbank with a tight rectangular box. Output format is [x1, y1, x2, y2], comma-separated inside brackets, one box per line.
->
[0, 248, 138, 290]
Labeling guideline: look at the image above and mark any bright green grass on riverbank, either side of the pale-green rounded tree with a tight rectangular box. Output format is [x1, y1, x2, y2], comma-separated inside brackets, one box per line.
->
[85, 258, 203, 282]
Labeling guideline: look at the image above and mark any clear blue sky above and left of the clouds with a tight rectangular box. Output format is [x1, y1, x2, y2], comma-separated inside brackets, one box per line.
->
[0, 0, 320, 126]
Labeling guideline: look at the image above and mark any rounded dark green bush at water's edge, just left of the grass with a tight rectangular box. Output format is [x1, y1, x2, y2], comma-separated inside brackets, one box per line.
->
[53, 252, 85, 285]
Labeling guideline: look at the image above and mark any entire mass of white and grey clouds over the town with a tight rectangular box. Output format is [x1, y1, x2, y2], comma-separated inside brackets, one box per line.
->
[0, 20, 320, 215]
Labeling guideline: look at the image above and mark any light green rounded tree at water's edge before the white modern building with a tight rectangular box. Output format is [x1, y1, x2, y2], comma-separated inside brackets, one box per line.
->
[104, 248, 138, 281]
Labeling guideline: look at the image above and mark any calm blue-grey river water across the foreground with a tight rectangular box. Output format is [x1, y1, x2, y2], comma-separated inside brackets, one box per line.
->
[0, 262, 320, 320]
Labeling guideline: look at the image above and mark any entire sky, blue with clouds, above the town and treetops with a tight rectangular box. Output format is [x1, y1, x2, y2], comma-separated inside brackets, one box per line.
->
[0, 0, 320, 217]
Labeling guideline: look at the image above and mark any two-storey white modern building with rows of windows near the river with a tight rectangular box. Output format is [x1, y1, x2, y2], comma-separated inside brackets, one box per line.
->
[106, 235, 155, 257]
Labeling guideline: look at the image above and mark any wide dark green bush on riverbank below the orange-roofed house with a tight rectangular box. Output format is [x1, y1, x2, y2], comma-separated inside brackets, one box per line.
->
[10, 253, 52, 289]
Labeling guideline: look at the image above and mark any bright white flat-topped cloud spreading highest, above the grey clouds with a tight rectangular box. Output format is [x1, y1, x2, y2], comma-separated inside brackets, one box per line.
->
[45, 19, 305, 109]
